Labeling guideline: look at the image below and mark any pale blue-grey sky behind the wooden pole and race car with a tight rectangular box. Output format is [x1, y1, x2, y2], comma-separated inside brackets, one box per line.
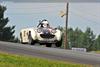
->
[1, 1, 100, 37]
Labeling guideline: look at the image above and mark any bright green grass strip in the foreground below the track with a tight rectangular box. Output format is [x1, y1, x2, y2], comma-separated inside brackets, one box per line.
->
[0, 52, 92, 67]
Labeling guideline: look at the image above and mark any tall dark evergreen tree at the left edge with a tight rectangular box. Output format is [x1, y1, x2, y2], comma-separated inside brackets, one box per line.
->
[0, 5, 15, 41]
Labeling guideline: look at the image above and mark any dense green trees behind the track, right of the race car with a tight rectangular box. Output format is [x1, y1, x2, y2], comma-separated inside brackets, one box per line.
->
[58, 27, 100, 51]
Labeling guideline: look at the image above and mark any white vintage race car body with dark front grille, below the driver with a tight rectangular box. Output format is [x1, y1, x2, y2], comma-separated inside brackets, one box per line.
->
[20, 19, 62, 47]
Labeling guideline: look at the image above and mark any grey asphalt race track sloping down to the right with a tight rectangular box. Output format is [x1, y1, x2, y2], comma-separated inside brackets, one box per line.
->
[0, 41, 100, 65]
